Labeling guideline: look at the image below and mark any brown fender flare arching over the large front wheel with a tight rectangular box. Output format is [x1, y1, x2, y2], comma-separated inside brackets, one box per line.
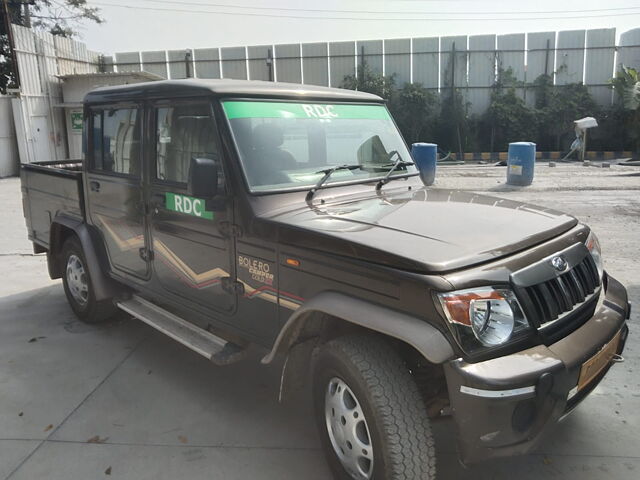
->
[262, 292, 454, 364]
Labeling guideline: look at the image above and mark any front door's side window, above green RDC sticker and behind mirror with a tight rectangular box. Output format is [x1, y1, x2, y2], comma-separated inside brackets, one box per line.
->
[156, 103, 224, 184]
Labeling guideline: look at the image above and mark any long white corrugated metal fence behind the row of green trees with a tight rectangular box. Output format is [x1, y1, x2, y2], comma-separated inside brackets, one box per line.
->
[106, 28, 640, 114]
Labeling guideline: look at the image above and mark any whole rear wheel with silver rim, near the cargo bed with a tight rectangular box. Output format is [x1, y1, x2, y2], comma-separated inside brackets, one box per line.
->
[61, 236, 118, 323]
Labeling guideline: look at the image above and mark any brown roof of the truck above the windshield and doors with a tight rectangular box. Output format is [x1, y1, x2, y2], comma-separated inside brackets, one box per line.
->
[84, 78, 384, 104]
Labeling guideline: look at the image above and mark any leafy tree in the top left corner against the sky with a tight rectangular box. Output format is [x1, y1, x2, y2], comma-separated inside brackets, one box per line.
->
[0, 0, 104, 94]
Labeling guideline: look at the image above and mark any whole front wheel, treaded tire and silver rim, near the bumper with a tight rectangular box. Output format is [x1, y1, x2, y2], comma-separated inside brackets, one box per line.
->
[313, 336, 436, 480]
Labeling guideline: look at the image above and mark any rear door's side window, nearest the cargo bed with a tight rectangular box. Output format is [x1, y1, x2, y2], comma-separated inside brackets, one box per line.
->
[92, 108, 141, 176]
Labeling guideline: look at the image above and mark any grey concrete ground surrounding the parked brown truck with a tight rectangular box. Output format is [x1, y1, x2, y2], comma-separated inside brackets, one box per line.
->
[0, 165, 640, 480]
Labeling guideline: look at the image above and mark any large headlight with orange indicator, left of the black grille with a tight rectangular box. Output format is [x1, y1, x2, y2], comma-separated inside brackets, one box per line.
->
[438, 287, 529, 352]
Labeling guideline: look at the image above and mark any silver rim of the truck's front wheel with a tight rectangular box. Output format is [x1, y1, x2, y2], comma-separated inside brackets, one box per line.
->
[324, 377, 373, 479]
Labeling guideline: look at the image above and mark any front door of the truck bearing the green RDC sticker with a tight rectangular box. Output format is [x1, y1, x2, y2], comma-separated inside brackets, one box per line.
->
[149, 101, 236, 313]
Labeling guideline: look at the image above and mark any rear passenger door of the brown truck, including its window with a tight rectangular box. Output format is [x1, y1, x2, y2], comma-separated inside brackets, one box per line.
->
[85, 104, 149, 279]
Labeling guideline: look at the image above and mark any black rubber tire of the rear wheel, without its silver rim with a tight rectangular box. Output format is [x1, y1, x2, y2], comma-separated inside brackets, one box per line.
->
[60, 236, 119, 323]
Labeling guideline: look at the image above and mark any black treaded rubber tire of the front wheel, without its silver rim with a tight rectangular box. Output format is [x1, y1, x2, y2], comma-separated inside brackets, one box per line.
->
[313, 335, 436, 480]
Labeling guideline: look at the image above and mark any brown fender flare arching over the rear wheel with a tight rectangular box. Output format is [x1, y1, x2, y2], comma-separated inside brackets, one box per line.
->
[47, 215, 122, 301]
